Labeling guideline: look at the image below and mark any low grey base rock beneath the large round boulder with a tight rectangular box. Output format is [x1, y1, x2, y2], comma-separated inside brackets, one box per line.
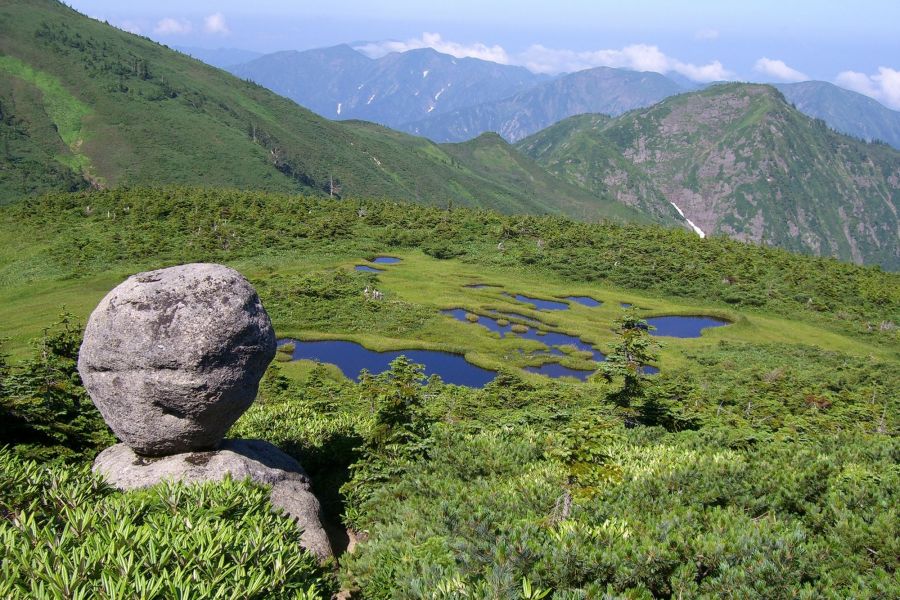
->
[94, 440, 332, 559]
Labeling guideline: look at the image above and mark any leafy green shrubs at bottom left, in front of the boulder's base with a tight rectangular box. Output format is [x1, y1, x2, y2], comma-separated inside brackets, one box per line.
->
[0, 448, 334, 599]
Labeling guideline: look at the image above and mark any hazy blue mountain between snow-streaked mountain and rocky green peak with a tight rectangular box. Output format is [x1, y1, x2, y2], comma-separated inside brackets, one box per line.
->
[400, 67, 684, 142]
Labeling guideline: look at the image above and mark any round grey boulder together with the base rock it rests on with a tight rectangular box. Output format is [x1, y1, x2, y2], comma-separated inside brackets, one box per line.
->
[78, 264, 332, 559]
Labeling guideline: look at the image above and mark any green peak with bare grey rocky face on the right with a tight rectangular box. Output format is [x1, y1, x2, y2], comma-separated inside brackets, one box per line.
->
[518, 84, 900, 269]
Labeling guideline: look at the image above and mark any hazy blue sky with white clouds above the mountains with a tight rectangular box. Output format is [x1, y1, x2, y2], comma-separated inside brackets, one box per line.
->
[69, 0, 900, 108]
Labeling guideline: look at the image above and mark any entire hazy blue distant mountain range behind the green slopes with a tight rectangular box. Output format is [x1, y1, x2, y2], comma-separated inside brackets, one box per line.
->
[229, 45, 900, 148]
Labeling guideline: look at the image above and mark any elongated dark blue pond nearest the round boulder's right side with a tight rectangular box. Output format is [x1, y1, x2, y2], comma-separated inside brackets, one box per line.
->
[279, 340, 496, 388]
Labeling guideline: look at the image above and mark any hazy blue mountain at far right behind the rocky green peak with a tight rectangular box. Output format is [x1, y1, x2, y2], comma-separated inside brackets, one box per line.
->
[775, 81, 900, 149]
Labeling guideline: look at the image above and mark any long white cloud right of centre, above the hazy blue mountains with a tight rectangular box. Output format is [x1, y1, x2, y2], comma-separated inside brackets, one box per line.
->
[520, 44, 732, 82]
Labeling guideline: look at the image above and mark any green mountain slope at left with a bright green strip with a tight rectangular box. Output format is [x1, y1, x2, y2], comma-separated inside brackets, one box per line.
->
[0, 0, 639, 223]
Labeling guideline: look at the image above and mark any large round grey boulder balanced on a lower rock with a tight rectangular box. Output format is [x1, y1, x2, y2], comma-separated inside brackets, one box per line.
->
[78, 264, 275, 456]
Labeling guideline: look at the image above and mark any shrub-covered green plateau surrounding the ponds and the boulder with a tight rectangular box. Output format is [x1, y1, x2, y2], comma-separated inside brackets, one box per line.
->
[0, 186, 900, 600]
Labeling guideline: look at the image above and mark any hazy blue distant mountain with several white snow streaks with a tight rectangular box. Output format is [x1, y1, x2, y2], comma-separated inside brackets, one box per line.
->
[230, 45, 546, 127]
